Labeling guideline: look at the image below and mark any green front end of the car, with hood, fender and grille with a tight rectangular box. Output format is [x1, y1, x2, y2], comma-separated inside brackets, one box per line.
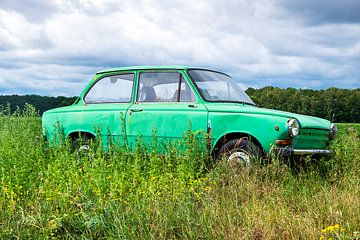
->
[207, 103, 330, 152]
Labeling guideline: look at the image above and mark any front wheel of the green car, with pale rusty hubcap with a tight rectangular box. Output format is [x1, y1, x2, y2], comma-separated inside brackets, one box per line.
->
[216, 138, 261, 167]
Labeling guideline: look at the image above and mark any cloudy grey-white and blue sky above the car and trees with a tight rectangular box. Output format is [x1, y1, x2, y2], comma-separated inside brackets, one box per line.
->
[0, 0, 360, 96]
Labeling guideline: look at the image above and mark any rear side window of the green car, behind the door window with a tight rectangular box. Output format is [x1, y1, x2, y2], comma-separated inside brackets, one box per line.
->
[85, 74, 134, 103]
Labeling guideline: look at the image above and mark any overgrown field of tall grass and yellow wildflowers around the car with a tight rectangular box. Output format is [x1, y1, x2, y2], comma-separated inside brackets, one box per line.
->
[0, 106, 360, 239]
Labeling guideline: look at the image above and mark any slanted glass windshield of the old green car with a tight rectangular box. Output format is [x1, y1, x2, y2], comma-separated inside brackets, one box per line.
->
[188, 69, 255, 105]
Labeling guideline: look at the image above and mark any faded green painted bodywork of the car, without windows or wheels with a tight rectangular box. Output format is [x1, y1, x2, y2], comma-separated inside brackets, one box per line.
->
[43, 66, 330, 155]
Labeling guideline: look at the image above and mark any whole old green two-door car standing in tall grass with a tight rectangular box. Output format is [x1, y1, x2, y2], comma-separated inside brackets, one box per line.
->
[42, 66, 336, 163]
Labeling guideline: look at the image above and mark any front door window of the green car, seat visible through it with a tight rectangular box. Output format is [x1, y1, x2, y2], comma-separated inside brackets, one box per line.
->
[138, 72, 196, 102]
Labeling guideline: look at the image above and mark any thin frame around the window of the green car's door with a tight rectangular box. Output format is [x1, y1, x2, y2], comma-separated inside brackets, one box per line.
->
[135, 70, 198, 104]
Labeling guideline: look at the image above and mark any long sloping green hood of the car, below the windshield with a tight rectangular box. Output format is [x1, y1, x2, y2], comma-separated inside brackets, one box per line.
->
[206, 103, 331, 130]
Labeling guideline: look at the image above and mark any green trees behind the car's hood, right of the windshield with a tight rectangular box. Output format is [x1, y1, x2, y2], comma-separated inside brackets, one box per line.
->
[246, 87, 360, 123]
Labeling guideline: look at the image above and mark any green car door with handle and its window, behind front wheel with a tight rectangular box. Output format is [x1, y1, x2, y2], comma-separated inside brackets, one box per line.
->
[126, 71, 207, 147]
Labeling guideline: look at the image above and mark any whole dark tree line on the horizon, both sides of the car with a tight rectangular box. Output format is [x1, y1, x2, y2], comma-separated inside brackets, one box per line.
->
[0, 87, 360, 123]
